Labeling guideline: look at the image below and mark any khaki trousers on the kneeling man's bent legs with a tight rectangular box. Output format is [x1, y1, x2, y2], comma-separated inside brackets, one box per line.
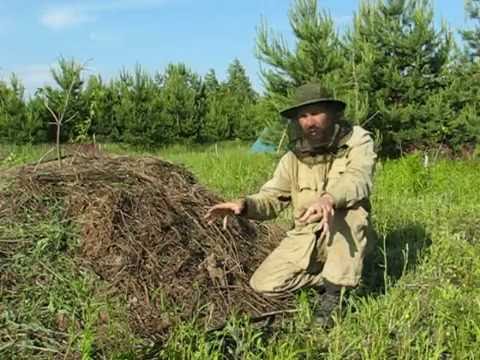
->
[250, 207, 372, 296]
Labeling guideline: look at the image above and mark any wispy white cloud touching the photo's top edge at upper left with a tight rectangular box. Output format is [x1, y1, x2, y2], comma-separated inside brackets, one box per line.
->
[40, 0, 168, 30]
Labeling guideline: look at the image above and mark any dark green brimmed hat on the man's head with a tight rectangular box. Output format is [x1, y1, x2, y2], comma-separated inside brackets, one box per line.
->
[280, 83, 347, 119]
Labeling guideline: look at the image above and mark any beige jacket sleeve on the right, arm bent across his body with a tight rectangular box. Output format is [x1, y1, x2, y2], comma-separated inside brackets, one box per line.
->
[327, 131, 377, 208]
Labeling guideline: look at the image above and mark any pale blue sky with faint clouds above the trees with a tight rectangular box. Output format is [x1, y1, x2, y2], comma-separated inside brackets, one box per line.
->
[0, 0, 472, 92]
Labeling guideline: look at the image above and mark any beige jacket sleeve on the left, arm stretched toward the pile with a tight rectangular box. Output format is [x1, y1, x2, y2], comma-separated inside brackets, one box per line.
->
[242, 153, 291, 220]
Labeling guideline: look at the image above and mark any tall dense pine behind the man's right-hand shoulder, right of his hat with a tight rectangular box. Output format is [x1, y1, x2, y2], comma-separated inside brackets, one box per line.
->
[343, 0, 452, 154]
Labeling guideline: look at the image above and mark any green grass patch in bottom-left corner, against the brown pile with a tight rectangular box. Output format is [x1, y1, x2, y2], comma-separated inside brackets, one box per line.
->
[0, 202, 139, 359]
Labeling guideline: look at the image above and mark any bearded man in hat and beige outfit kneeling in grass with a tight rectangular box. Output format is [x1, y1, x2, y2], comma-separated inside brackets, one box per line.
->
[206, 84, 376, 325]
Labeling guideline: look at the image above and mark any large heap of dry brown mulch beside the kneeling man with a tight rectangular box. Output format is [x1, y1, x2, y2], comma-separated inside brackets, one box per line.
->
[0, 156, 289, 337]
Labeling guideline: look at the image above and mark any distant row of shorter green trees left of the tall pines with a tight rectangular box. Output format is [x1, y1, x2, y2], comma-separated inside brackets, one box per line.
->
[0, 58, 261, 146]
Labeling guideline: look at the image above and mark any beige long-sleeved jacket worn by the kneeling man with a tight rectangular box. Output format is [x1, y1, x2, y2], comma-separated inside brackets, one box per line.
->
[244, 126, 377, 228]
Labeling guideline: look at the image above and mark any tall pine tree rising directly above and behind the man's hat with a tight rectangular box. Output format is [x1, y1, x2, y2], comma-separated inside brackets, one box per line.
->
[256, 0, 344, 100]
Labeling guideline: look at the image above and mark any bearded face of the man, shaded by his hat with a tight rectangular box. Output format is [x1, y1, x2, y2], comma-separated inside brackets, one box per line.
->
[297, 104, 336, 143]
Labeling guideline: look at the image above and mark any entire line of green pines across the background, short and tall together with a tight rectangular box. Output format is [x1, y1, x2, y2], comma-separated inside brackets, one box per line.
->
[0, 0, 480, 155]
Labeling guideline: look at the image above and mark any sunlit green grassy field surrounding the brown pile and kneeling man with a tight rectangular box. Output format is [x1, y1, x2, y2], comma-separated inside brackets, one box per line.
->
[0, 143, 480, 359]
